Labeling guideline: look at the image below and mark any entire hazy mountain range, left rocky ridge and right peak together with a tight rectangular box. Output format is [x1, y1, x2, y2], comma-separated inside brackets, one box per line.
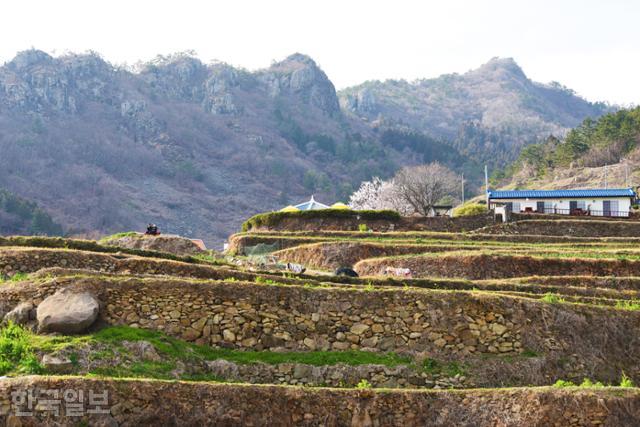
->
[0, 50, 605, 244]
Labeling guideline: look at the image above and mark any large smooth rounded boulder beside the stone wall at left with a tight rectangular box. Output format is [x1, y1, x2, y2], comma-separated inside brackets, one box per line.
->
[37, 289, 100, 334]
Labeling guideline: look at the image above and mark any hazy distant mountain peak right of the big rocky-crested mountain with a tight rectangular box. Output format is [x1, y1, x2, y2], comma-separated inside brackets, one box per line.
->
[339, 58, 611, 166]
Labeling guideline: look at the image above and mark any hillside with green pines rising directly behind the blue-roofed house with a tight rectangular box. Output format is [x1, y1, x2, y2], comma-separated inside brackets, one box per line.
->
[493, 107, 640, 189]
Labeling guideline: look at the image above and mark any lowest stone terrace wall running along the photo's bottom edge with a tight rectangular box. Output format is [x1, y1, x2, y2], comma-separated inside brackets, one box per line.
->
[0, 377, 640, 427]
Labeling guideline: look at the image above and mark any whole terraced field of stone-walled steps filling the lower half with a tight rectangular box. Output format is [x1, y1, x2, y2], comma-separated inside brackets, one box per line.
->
[0, 212, 640, 426]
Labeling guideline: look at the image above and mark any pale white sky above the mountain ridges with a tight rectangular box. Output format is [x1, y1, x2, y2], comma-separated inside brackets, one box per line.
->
[0, 0, 640, 105]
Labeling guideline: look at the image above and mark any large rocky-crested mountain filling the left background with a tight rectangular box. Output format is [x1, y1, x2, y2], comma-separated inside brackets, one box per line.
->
[0, 51, 422, 244]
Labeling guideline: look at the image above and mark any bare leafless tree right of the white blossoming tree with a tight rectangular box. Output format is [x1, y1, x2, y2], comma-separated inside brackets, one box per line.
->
[393, 162, 459, 216]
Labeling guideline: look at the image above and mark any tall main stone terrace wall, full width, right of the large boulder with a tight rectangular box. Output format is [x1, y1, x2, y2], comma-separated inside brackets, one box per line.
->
[0, 277, 640, 381]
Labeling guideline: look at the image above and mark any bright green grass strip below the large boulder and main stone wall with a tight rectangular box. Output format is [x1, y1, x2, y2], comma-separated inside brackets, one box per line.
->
[0, 324, 412, 379]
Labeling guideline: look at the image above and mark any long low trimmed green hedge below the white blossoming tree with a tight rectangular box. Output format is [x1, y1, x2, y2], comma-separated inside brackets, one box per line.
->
[242, 209, 400, 232]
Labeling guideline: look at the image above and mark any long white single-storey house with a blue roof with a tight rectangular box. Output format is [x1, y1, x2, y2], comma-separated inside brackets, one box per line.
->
[488, 188, 636, 217]
